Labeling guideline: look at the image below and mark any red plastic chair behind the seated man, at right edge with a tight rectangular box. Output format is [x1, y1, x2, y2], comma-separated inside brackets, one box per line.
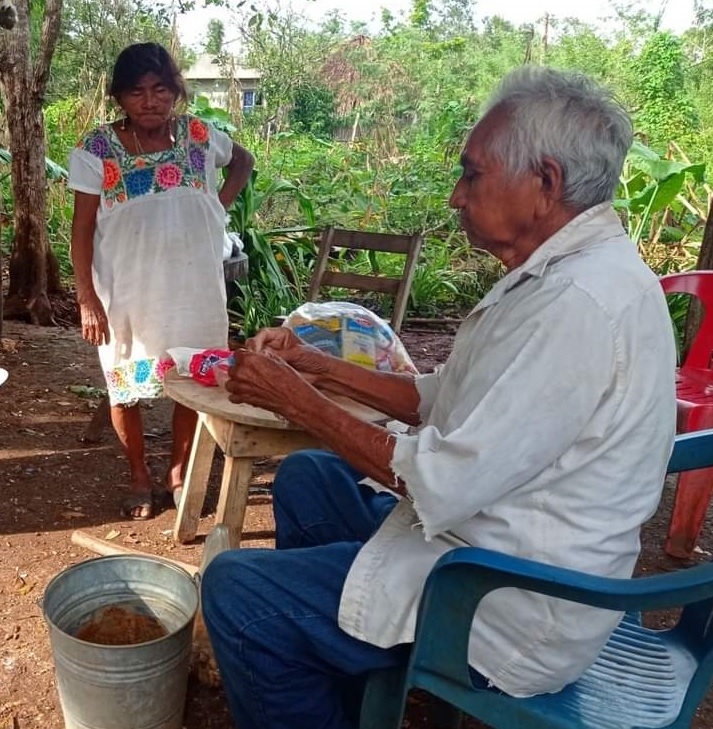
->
[660, 271, 713, 558]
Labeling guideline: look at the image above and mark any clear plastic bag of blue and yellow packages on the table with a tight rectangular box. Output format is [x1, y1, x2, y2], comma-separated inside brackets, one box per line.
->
[283, 301, 417, 374]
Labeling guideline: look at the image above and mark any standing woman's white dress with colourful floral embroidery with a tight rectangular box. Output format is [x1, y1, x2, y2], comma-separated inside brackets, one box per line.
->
[69, 115, 232, 405]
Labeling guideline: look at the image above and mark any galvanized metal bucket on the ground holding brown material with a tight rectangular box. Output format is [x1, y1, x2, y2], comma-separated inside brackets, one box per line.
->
[42, 555, 198, 729]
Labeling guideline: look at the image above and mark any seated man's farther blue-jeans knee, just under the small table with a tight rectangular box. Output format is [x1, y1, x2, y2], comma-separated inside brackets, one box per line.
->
[272, 450, 396, 549]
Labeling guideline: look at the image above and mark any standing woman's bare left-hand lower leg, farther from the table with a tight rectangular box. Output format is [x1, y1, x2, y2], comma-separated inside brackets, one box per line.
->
[110, 403, 152, 519]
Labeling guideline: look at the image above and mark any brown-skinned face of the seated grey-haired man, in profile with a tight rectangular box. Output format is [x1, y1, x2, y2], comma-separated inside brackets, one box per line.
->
[450, 107, 542, 268]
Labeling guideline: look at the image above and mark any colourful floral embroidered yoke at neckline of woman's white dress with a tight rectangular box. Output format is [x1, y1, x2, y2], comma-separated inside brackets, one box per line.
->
[77, 115, 210, 208]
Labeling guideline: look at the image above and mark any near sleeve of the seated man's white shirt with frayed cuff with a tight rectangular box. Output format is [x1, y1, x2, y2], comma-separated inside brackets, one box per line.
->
[391, 287, 615, 540]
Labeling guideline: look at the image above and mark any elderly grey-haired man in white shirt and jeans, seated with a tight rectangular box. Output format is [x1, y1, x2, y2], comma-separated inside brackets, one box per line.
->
[203, 67, 675, 729]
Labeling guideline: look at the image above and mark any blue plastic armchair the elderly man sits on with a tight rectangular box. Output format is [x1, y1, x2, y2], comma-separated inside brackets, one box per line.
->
[360, 430, 713, 729]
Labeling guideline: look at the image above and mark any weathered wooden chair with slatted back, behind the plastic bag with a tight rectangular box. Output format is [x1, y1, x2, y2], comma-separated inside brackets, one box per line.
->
[307, 227, 423, 334]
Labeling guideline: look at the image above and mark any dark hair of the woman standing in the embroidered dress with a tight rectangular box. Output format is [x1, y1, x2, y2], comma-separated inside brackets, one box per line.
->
[109, 43, 188, 103]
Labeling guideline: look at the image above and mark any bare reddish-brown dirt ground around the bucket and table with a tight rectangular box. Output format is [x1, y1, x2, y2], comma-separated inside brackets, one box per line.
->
[0, 314, 713, 729]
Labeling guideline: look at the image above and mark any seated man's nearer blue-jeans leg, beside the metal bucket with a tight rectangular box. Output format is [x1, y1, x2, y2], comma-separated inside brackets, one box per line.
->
[202, 541, 405, 729]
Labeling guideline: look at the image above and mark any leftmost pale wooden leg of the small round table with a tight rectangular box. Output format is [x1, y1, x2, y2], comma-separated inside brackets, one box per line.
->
[173, 416, 215, 543]
